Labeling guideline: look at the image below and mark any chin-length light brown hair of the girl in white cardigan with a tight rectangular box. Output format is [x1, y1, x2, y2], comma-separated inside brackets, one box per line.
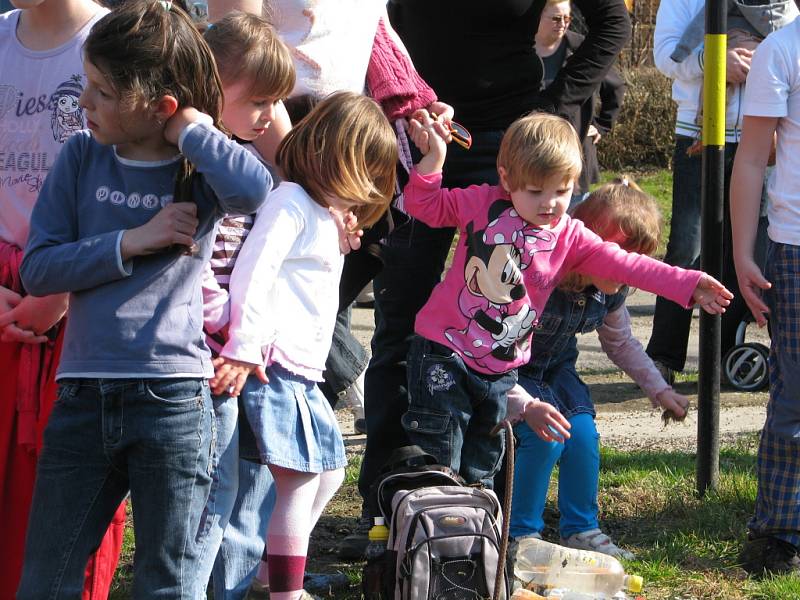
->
[275, 92, 397, 227]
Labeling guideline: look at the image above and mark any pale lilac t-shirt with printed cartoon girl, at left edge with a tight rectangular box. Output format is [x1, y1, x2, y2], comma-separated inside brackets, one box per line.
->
[0, 9, 108, 248]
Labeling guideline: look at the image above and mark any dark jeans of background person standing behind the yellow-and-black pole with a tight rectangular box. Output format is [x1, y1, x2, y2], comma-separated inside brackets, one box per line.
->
[647, 136, 765, 371]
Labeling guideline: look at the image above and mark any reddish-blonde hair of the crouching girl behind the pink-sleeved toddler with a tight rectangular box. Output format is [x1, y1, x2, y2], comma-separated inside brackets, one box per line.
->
[558, 175, 661, 292]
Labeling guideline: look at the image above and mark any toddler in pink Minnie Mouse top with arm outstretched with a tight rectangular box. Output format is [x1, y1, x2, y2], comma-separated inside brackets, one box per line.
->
[403, 111, 732, 486]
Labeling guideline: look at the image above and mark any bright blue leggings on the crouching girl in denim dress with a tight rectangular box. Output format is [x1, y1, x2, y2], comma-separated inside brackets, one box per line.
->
[511, 413, 600, 538]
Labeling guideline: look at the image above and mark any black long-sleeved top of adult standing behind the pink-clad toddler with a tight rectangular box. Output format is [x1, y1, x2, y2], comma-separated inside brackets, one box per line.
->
[389, 0, 631, 134]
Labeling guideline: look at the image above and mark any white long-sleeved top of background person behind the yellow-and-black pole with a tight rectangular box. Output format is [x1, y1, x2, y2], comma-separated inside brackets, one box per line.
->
[653, 0, 744, 142]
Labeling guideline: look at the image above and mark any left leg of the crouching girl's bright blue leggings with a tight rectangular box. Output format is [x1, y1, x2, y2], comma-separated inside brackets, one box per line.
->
[511, 422, 569, 537]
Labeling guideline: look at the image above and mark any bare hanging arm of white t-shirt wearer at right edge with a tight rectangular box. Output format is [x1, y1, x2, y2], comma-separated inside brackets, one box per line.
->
[730, 116, 778, 327]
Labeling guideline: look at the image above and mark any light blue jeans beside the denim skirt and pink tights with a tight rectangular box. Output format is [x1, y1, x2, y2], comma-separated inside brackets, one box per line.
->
[196, 396, 275, 600]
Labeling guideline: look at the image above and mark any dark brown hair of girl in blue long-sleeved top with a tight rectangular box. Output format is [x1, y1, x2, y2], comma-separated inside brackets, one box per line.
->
[84, 0, 222, 202]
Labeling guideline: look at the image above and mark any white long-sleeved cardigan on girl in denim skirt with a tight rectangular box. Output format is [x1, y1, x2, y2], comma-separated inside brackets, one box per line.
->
[220, 182, 344, 381]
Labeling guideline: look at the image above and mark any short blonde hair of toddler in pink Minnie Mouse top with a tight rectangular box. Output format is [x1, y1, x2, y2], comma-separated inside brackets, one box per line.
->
[497, 113, 583, 192]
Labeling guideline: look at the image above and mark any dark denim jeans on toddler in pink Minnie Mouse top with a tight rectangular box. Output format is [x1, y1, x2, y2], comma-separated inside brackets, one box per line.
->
[402, 336, 517, 488]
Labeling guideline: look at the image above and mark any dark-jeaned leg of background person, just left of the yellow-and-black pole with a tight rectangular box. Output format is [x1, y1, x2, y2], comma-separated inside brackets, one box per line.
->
[647, 136, 702, 371]
